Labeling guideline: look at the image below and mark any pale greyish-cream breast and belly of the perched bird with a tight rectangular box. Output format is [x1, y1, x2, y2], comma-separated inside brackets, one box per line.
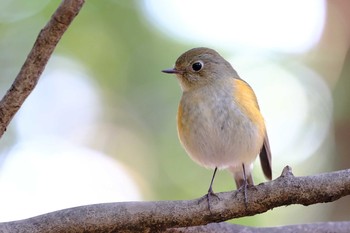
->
[177, 81, 263, 168]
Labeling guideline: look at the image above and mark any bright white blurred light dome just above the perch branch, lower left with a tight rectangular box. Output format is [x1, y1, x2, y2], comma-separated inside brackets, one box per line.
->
[0, 138, 142, 222]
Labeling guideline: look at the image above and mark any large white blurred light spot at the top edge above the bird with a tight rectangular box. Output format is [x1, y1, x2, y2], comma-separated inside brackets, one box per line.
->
[143, 0, 326, 53]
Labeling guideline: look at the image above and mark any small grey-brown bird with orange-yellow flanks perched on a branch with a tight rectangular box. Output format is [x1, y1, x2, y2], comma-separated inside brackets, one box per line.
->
[162, 47, 272, 208]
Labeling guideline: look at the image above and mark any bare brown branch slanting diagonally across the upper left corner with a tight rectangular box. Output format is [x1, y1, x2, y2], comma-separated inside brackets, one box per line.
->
[0, 0, 84, 137]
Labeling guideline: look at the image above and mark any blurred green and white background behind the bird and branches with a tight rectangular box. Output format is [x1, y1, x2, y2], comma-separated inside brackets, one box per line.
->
[0, 0, 350, 226]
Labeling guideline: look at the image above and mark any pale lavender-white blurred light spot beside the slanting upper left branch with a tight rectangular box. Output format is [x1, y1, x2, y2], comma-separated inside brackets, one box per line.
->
[15, 56, 102, 142]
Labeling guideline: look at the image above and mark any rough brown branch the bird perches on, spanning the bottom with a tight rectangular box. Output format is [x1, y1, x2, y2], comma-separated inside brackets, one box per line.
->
[0, 166, 350, 233]
